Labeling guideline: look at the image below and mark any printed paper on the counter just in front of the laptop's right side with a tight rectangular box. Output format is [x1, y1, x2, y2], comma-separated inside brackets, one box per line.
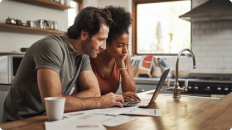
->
[123, 108, 162, 116]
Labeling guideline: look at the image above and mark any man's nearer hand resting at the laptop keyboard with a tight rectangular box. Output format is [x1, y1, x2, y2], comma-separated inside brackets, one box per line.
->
[99, 93, 124, 108]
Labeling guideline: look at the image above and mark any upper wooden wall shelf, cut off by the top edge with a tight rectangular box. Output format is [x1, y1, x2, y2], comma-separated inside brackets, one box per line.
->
[16, 0, 72, 10]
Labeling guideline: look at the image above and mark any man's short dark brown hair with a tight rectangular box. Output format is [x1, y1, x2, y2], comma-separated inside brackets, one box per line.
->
[68, 7, 113, 39]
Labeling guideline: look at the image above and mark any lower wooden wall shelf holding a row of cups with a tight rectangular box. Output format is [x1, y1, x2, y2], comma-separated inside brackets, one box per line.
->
[0, 23, 64, 34]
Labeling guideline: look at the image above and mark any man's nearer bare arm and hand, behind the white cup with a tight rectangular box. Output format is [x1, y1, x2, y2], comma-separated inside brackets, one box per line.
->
[37, 68, 124, 112]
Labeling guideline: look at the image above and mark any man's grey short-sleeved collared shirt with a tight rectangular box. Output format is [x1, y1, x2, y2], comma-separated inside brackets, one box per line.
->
[3, 33, 91, 122]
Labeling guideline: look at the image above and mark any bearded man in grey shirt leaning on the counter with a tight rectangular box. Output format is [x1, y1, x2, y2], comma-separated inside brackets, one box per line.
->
[3, 7, 123, 122]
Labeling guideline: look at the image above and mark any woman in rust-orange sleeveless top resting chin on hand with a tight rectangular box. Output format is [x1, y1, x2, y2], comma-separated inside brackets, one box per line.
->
[73, 6, 140, 101]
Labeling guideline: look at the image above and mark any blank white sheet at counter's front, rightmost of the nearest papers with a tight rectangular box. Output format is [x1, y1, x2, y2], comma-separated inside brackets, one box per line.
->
[102, 115, 136, 127]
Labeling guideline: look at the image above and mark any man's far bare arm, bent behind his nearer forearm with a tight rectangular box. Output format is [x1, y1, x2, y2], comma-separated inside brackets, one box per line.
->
[75, 70, 101, 98]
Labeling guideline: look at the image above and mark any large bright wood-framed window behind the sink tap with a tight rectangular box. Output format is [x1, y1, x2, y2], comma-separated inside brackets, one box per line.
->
[132, 0, 191, 55]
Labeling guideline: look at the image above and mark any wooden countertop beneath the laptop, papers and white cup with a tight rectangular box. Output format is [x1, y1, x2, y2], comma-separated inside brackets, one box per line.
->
[0, 93, 232, 130]
